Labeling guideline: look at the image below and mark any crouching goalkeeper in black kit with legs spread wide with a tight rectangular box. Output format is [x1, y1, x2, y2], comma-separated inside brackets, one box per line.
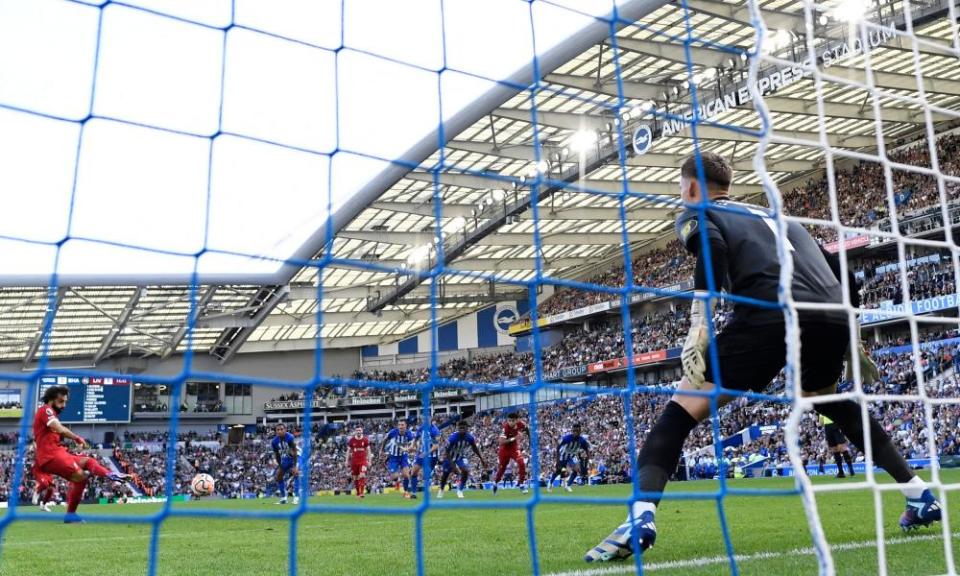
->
[585, 152, 940, 562]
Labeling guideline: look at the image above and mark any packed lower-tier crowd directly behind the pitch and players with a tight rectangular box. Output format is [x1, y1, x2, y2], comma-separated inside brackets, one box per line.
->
[7, 366, 960, 502]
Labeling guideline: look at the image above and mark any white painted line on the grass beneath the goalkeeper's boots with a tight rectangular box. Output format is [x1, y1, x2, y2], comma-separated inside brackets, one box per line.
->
[545, 532, 960, 576]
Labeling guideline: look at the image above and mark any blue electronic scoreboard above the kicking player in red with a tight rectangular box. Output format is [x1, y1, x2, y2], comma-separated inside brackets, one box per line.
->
[37, 376, 133, 424]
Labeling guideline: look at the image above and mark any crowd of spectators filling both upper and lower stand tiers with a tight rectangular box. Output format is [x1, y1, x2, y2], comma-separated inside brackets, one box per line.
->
[0, 135, 960, 500]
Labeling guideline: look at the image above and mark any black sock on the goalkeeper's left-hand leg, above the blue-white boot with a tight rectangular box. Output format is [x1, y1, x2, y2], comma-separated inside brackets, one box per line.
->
[637, 400, 699, 506]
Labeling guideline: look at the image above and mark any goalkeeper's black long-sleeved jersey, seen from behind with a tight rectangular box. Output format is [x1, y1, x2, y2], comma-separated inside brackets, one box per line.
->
[676, 200, 847, 325]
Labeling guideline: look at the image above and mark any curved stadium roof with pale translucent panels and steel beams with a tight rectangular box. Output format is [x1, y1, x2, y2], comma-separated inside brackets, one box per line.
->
[0, 0, 960, 365]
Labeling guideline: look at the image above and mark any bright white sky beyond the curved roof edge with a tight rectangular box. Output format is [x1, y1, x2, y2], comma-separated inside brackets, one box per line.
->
[0, 0, 662, 286]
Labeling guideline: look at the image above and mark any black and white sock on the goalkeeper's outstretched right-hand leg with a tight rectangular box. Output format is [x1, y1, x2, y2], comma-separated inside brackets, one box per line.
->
[814, 400, 912, 488]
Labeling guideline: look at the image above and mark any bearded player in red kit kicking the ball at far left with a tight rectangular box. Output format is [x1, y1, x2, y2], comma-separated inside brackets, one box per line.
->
[33, 386, 127, 524]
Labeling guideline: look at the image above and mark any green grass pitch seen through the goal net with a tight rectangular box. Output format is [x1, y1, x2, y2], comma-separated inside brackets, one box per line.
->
[0, 471, 960, 576]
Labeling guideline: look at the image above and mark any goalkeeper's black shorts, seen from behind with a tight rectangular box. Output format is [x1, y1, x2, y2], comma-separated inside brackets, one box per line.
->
[705, 321, 850, 392]
